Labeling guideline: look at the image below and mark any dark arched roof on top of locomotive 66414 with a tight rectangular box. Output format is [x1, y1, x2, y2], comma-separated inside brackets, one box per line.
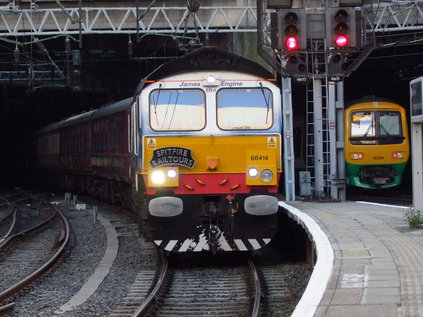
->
[136, 46, 275, 94]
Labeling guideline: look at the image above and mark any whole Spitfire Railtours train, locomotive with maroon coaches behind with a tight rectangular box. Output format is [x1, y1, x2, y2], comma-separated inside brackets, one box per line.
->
[36, 48, 282, 252]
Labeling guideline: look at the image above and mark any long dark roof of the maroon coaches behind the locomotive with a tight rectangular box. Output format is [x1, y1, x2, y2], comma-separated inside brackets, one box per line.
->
[36, 97, 133, 134]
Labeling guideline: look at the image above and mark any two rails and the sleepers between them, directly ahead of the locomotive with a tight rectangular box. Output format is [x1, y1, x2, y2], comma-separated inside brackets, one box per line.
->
[132, 254, 261, 317]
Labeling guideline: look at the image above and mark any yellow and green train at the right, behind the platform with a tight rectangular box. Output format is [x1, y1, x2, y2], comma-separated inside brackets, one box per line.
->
[344, 96, 410, 189]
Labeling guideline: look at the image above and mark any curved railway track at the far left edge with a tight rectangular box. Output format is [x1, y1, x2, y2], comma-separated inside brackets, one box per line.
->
[0, 193, 70, 311]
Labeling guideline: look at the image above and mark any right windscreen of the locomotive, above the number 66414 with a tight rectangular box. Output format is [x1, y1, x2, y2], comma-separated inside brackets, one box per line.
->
[217, 88, 273, 130]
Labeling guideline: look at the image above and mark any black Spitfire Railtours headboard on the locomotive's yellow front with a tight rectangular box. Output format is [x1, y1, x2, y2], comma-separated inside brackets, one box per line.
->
[150, 146, 195, 168]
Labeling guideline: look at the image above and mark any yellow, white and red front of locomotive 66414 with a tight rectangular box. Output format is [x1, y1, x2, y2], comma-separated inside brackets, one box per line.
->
[138, 70, 282, 252]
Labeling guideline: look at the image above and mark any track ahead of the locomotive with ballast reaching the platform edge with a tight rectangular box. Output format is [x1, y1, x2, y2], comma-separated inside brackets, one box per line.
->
[114, 251, 311, 317]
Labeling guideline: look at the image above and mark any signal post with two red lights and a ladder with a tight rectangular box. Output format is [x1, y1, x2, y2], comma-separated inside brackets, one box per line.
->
[257, 0, 374, 200]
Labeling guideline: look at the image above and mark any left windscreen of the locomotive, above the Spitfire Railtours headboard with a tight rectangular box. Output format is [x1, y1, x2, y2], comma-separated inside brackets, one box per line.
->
[150, 89, 206, 131]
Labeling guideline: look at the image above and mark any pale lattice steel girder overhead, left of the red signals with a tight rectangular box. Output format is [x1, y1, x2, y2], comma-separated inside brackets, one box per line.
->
[0, 6, 257, 37]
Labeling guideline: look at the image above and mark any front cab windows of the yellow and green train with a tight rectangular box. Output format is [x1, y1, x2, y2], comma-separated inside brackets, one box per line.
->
[350, 111, 404, 144]
